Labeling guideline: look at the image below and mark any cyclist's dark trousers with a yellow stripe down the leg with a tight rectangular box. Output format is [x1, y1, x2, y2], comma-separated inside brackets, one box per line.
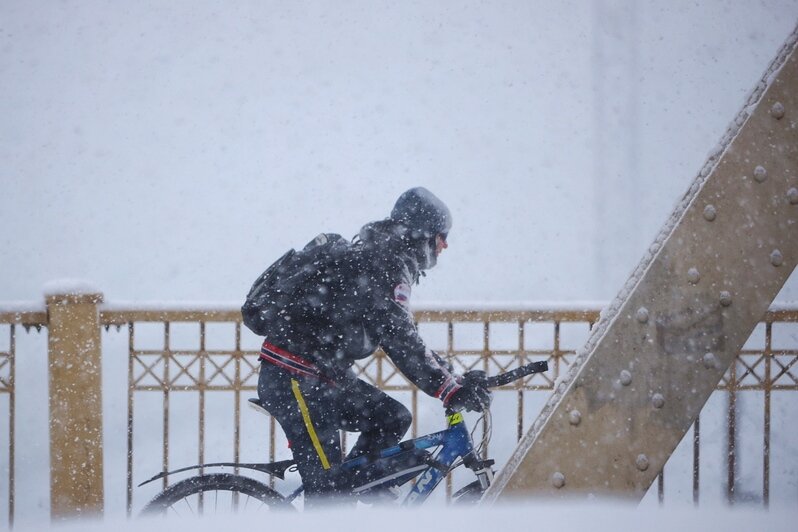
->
[258, 362, 412, 504]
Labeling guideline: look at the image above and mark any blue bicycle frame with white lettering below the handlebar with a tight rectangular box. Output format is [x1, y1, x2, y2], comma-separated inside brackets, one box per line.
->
[341, 412, 482, 505]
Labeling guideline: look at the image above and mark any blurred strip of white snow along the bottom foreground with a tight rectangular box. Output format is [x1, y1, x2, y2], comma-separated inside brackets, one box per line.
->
[15, 501, 795, 532]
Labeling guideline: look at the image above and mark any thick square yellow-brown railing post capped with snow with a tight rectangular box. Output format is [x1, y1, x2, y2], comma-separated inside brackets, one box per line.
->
[46, 292, 103, 520]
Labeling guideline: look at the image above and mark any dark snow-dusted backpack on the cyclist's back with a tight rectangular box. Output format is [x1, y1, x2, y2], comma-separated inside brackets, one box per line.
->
[241, 233, 351, 336]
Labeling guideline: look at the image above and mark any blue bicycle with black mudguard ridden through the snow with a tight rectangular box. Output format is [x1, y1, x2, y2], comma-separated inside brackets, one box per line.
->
[139, 361, 548, 515]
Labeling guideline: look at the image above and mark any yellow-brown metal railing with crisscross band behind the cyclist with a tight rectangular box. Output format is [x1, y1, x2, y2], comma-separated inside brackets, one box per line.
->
[0, 306, 798, 526]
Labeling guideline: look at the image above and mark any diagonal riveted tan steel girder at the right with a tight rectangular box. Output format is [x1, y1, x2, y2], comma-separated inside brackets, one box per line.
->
[483, 21, 798, 503]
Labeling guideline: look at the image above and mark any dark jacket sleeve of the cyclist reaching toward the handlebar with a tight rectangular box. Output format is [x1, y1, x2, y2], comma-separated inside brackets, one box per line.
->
[372, 276, 461, 405]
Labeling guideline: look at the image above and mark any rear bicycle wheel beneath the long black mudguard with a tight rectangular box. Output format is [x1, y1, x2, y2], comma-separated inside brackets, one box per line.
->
[141, 473, 294, 515]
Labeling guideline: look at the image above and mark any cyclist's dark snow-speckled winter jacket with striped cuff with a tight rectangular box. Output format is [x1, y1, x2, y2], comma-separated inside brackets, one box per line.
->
[253, 221, 460, 401]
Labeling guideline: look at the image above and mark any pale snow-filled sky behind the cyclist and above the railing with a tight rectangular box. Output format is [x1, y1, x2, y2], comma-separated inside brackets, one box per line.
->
[0, 0, 798, 528]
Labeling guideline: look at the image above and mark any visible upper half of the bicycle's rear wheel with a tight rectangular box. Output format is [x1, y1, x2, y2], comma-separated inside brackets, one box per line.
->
[141, 473, 294, 516]
